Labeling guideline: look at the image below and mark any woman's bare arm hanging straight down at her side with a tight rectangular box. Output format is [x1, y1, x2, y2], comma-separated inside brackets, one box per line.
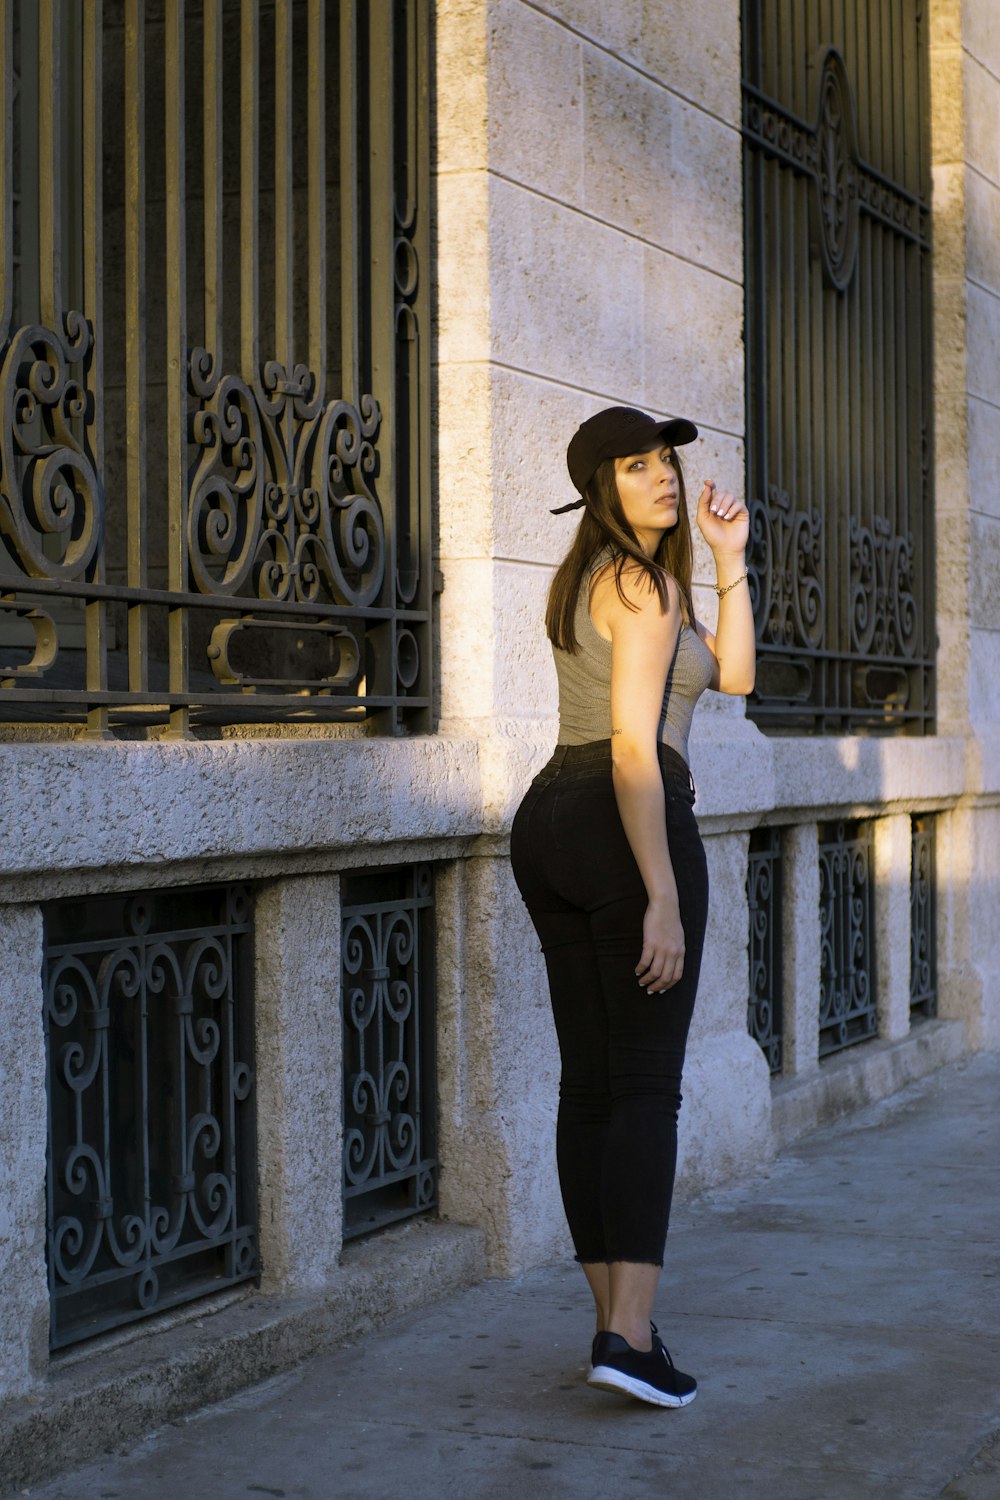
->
[592, 569, 684, 995]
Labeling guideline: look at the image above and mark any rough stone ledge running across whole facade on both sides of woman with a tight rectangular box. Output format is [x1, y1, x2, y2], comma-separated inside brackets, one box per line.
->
[0, 729, 1000, 902]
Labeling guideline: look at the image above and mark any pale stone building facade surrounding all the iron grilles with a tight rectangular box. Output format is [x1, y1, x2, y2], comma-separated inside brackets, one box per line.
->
[0, 0, 1000, 1478]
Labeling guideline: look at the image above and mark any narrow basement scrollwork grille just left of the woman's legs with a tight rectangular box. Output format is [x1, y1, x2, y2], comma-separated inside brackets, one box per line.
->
[342, 864, 438, 1239]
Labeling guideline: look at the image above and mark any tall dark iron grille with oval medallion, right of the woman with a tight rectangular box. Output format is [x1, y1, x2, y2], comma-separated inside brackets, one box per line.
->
[742, 0, 934, 734]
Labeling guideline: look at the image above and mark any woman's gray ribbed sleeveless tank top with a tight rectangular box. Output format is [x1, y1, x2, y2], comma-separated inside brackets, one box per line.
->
[552, 554, 714, 764]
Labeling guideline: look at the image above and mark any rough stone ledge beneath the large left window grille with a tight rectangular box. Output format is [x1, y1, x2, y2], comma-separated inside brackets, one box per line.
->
[0, 735, 481, 899]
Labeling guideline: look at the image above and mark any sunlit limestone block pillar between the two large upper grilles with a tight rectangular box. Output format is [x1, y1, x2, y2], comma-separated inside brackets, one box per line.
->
[436, 0, 744, 729]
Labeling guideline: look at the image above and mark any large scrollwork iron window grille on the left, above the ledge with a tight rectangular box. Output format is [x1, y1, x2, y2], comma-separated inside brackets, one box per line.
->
[0, 0, 435, 737]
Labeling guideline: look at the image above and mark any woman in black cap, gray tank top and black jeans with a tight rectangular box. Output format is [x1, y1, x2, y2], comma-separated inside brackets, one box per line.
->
[511, 407, 754, 1407]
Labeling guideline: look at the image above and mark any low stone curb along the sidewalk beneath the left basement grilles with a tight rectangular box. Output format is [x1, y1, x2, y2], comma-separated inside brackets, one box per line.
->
[0, 1220, 486, 1494]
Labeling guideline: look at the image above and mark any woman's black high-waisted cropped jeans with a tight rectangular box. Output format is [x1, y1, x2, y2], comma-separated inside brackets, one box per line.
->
[511, 740, 708, 1266]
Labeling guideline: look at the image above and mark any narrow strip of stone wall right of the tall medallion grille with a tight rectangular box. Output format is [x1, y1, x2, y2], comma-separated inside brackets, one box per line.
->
[930, 0, 1000, 1046]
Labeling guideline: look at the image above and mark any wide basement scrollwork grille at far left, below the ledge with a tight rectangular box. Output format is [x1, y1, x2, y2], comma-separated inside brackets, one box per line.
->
[43, 885, 258, 1349]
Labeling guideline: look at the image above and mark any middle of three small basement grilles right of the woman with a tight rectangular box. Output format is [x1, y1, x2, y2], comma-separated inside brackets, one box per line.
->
[819, 822, 879, 1058]
